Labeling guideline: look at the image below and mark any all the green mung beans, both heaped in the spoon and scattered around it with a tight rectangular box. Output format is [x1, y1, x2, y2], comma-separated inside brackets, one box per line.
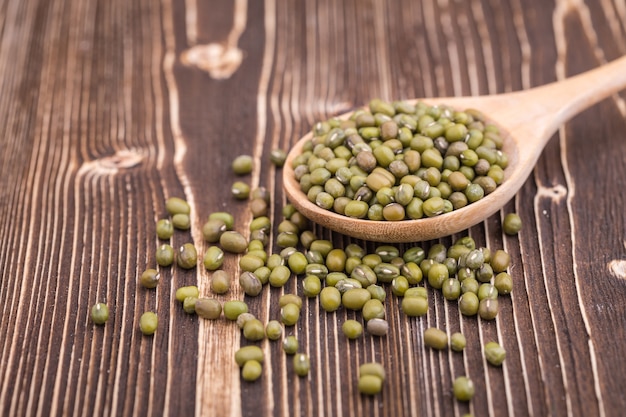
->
[91, 100, 521, 412]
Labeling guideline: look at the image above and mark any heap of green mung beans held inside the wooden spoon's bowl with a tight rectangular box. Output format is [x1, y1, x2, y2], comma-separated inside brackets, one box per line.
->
[293, 99, 508, 221]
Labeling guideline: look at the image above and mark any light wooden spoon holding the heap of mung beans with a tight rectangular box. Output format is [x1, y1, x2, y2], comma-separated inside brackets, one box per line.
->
[283, 56, 626, 242]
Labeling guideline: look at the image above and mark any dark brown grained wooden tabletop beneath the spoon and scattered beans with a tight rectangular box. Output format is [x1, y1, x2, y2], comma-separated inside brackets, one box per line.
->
[0, 0, 626, 416]
